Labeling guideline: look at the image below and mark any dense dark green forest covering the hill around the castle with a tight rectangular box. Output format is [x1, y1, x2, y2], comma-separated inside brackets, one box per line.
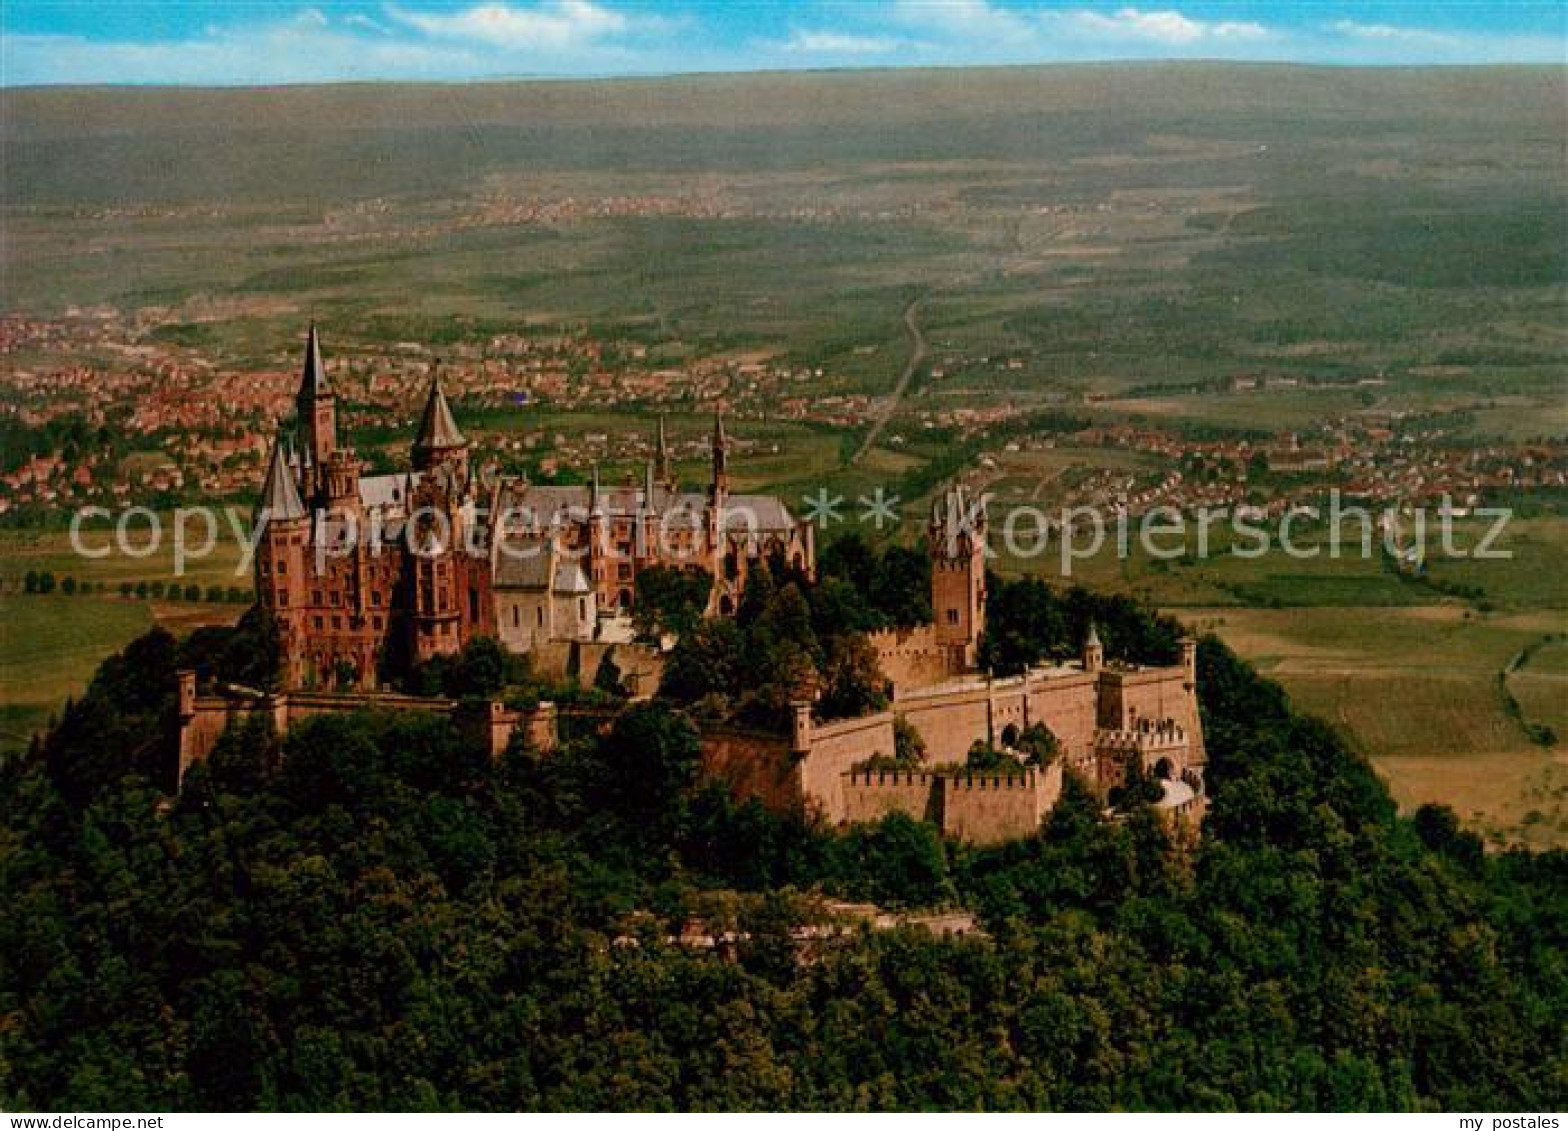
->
[0, 571, 1568, 1111]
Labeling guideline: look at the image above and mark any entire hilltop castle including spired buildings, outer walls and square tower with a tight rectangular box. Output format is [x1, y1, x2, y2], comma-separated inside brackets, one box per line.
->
[179, 326, 1207, 844]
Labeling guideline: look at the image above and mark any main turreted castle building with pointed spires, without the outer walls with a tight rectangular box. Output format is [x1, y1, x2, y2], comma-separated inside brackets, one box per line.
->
[256, 325, 815, 689]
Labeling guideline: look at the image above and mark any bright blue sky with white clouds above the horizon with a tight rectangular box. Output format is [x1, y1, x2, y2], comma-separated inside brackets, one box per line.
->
[0, 0, 1568, 86]
